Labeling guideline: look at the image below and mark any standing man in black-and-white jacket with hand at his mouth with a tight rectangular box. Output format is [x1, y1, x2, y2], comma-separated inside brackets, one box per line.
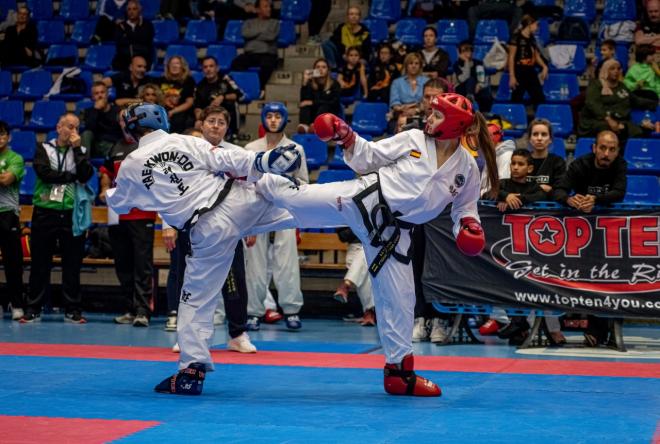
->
[21, 113, 94, 324]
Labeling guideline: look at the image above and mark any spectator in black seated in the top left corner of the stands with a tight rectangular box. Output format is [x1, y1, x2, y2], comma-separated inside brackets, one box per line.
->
[0, 6, 43, 68]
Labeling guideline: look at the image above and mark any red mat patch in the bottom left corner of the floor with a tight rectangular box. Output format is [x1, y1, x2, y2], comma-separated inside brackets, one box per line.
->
[0, 415, 160, 444]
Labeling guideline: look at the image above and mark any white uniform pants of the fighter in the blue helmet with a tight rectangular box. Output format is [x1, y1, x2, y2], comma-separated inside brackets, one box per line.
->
[177, 185, 296, 371]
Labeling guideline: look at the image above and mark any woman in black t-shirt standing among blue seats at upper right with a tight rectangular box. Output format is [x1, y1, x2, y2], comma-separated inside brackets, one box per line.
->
[508, 14, 548, 108]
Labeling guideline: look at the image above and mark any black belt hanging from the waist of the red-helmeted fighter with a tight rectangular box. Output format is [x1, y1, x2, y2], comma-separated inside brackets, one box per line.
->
[353, 174, 414, 276]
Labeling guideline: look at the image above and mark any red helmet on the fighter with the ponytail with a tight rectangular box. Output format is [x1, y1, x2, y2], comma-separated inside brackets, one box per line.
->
[424, 93, 474, 139]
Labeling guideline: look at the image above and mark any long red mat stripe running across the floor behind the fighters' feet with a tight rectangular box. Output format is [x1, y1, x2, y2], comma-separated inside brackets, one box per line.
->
[0, 342, 660, 378]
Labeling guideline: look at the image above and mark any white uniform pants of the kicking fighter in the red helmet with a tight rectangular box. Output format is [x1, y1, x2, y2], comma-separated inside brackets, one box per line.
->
[257, 174, 415, 364]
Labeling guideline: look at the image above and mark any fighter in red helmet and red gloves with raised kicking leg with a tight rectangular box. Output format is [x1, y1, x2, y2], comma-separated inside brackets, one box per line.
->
[257, 93, 497, 396]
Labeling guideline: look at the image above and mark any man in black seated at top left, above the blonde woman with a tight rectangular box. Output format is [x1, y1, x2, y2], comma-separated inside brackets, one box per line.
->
[112, 0, 155, 71]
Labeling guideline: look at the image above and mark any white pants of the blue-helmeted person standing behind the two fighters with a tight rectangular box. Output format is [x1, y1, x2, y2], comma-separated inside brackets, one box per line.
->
[245, 229, 303, 317]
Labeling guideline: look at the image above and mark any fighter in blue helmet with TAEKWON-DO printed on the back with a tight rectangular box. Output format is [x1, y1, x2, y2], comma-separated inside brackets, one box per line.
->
[107, 103, 300, 395]
